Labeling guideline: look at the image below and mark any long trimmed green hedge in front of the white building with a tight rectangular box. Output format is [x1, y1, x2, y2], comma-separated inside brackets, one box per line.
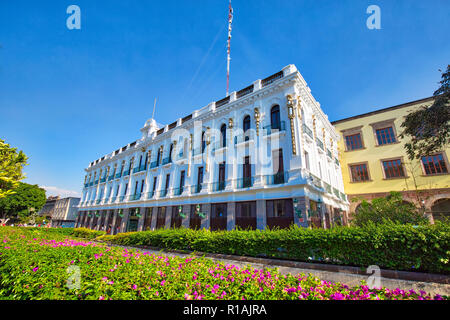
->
[97, 223, 450, 274]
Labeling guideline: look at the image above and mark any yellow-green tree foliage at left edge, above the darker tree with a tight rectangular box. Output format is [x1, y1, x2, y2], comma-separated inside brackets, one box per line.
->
[0, 139, 28, 199]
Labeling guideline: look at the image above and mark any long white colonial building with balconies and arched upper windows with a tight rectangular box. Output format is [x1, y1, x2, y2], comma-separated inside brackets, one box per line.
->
[76, 65, 348, 234]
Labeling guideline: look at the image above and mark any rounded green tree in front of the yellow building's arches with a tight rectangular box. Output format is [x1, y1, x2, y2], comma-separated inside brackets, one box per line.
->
[352, 191, 429, 227]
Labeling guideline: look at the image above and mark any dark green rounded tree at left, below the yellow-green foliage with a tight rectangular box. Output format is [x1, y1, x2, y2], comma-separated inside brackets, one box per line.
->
[0, 182, 47, 218]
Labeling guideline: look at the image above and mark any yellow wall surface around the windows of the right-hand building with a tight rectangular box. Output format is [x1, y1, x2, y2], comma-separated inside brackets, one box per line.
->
[333, 99, 450, 195]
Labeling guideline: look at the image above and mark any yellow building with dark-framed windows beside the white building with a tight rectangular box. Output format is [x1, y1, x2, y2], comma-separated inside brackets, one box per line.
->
[332, 97, 450, 219]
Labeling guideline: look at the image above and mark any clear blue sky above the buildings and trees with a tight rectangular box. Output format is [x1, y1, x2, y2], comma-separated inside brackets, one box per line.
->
[0, 0, 450, 195]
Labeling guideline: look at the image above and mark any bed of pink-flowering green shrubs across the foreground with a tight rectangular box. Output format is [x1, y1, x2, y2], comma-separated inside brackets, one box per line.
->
[0, 227, 447, 300]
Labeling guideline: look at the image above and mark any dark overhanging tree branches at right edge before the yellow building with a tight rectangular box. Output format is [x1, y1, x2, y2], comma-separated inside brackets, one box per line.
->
[400, 65, 450, 160]
